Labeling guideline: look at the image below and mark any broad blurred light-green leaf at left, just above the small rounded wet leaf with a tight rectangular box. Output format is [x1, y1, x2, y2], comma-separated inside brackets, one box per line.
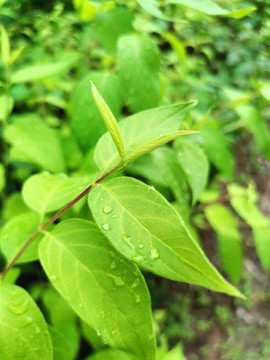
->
[4, 114, 65, 172]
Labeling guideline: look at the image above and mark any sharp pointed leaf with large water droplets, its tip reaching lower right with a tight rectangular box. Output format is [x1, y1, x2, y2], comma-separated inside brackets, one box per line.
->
[88, 177, 241, 296]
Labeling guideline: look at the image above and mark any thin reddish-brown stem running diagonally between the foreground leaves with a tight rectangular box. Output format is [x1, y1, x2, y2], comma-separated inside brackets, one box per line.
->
[0, 165, 119, 281]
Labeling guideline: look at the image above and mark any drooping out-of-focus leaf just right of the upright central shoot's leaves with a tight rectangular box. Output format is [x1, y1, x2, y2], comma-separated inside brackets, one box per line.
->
[174, 139, 209, 205]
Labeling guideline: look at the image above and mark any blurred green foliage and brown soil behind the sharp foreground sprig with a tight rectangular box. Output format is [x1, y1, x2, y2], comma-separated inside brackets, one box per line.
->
[0, 0, 270, 360]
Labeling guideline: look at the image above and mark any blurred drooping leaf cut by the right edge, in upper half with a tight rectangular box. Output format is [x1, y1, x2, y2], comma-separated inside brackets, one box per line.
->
[235, 105, 270, 160]
